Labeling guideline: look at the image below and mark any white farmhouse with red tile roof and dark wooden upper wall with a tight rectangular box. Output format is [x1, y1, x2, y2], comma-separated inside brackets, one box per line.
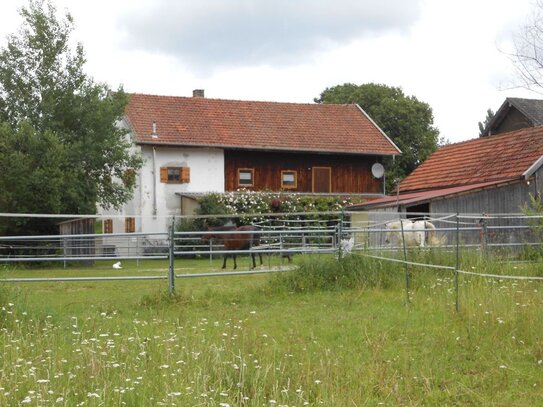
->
[104, 90, 401, 232]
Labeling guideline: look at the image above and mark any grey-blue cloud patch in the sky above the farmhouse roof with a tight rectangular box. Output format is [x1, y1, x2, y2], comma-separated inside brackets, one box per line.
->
[120, 0, 420, 71]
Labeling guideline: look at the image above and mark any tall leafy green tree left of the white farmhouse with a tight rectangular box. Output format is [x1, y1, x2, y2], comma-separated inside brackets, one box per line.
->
[0, 0, 142, 234]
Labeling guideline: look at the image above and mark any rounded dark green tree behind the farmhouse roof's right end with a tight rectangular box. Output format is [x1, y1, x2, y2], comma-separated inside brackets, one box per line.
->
[315, 83, 440, 190]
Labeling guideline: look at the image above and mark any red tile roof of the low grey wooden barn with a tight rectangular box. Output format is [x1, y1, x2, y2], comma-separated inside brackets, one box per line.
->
[400, 126, 543, 194]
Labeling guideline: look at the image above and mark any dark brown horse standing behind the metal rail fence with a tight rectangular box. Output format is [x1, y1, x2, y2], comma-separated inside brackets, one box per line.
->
[202, 225, 262, 270]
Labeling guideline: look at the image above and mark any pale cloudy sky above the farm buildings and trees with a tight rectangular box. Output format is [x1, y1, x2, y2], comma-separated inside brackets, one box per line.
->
[0, 0, 543, 142]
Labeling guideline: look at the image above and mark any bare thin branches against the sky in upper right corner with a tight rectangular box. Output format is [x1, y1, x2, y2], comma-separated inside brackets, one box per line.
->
[510, 0, 543, 93]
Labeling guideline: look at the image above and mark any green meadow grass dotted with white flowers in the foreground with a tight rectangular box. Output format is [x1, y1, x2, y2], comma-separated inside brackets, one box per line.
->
[0, 251, 543, 406]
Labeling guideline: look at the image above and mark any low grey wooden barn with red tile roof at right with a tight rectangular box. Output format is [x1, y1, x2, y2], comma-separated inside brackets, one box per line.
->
[353, 126, 543, 217]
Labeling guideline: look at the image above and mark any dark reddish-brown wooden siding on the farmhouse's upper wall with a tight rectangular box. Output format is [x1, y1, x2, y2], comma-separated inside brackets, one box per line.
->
[224, 150, 383, 193]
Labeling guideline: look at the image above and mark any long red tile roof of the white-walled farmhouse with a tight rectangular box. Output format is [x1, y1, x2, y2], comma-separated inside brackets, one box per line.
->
[126, 94, 400, 155]
